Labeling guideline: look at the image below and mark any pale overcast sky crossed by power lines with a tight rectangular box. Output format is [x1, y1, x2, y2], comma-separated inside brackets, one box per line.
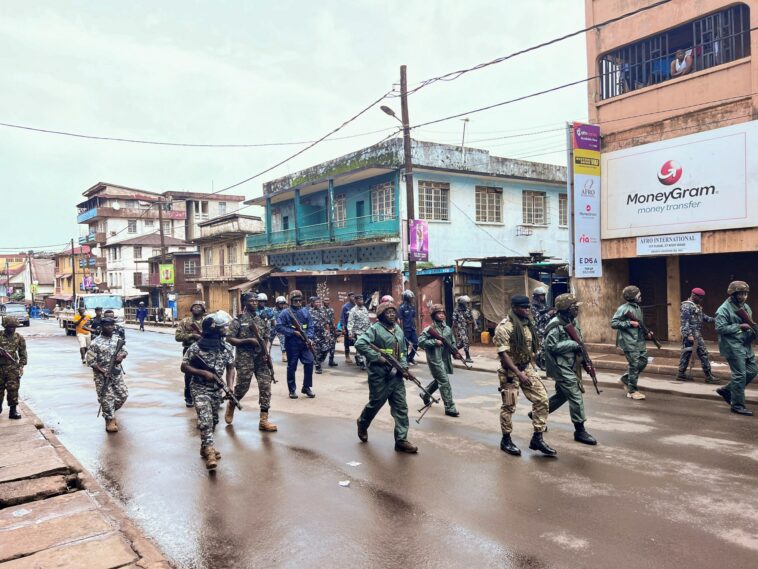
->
[0, 0, 587, 250]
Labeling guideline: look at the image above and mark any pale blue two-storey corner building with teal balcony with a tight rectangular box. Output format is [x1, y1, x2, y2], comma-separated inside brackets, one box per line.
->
[245, 139, 568, 318]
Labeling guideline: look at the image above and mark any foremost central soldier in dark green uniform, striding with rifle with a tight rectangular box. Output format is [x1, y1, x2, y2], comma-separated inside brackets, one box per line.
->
[355, 303, 418, 453]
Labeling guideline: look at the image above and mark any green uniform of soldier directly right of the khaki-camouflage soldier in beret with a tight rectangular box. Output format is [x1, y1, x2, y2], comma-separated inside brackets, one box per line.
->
[544, 316, 586, 423]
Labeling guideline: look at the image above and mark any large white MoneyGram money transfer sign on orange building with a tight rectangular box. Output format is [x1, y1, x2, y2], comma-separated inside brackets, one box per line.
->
[601, 121, 758, 239]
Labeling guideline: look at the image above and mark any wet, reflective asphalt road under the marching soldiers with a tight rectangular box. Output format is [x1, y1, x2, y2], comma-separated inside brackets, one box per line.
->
[11, 321, 758, 569]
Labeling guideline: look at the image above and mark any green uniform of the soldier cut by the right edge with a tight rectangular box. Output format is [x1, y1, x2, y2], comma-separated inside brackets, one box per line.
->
[716, 298, 758, 407]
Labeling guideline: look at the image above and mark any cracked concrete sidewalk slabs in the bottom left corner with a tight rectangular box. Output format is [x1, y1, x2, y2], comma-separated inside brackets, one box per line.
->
[0, 403, 170, 569]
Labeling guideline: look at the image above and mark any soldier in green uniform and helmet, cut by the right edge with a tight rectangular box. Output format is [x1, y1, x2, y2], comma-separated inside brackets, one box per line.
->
[716, 281, 758, 416]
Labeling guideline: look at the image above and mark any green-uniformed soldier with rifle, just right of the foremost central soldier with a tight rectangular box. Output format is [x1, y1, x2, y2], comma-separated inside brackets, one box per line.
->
[418, 304, 460, 417]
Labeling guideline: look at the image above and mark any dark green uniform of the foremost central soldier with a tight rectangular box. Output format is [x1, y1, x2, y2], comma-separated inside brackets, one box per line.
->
[355, 322, 408, 441]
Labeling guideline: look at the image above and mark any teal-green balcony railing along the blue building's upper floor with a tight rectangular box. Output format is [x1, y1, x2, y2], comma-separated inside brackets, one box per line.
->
[246, 215, 400, 253]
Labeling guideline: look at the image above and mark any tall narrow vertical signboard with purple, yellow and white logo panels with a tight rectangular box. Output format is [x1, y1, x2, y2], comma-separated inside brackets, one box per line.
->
[569, 123, 603, 279]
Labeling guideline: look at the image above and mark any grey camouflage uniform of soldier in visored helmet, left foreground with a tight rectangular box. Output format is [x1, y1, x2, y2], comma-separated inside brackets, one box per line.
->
[182, 342, 234, 447]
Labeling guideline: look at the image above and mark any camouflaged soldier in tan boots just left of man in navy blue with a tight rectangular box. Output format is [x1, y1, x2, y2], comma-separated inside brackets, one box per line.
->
[224, 292, 277, 433]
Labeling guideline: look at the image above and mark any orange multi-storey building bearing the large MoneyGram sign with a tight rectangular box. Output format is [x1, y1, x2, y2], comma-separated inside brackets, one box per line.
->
[574, 0, 758, 341]
